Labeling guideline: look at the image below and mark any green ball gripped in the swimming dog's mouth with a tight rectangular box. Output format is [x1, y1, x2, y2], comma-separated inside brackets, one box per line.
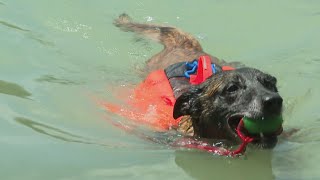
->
[242, 116, 283, 134]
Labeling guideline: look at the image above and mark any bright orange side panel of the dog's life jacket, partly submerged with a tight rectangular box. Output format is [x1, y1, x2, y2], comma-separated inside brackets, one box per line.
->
[104, 70, 179, 130]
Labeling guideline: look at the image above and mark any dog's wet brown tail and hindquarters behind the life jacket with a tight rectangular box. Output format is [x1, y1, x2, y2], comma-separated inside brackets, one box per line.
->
[114, 14, 206, 71]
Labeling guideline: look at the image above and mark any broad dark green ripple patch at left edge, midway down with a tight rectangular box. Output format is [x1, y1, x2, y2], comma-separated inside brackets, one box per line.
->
[0, 80, 31, 98]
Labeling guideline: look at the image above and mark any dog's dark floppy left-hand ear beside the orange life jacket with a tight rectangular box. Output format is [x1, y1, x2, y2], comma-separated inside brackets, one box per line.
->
[173, 88, 200, 119]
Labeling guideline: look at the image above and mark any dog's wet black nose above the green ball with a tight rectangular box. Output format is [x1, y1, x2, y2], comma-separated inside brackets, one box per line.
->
[263, 95, 283, 114]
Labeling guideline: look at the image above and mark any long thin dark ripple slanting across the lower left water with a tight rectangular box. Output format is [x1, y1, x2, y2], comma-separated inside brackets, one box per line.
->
[14, 117, 124, 148]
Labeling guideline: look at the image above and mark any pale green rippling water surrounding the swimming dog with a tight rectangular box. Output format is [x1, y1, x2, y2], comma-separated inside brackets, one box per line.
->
[0, 0, 320, 180]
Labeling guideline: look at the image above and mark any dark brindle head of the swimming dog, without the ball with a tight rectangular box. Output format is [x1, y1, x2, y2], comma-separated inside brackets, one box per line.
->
[173, 68, 282, 148]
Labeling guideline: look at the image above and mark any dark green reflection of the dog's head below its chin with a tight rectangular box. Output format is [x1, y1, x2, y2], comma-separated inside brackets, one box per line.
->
[175, 151, 274, 180]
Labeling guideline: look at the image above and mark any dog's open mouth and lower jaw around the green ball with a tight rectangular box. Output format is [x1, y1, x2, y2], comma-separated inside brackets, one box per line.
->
[227, 115, 283, 149]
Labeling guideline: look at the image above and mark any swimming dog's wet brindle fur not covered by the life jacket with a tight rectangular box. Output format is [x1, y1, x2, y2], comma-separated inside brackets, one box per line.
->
[114, 14, 282, 148]
